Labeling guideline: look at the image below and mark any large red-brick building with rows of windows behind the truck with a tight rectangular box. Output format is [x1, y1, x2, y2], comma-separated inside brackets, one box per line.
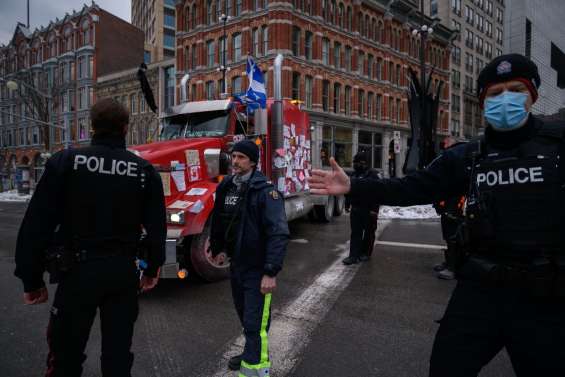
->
[176, 0, 452, 175]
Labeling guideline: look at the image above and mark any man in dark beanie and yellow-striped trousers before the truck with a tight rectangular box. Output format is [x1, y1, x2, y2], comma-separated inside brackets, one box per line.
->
[210, 140, 289, 377]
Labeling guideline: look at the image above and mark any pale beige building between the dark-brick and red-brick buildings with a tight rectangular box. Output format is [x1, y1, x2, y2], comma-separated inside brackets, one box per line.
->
[95, 59, 175, 145]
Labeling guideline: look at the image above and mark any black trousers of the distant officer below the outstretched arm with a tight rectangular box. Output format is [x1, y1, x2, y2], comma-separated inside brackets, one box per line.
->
[349, 207, 378, 258]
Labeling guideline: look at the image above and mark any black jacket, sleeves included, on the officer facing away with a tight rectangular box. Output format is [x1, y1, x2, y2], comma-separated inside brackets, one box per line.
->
[15, 135, 166, 292]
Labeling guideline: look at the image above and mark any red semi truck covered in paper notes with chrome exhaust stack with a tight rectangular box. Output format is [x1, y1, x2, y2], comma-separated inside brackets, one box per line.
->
[131, 56, 344, 281]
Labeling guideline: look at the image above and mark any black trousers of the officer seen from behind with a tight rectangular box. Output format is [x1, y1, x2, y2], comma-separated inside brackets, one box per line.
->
[46, 257, 139, 377]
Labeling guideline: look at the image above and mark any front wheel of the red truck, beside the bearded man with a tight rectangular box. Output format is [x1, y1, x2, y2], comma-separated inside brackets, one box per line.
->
[190, 224, 230, 282]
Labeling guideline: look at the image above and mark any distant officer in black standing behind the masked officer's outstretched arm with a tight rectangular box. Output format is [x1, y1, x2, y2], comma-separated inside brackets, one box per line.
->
[343, 152, 379, 265]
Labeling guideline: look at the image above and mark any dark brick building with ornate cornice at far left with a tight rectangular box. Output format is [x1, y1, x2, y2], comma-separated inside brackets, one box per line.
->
[0, 2, 144, 188]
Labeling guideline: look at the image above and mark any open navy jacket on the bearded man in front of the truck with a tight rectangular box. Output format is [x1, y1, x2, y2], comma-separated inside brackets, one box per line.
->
[210, 171, 290, 276]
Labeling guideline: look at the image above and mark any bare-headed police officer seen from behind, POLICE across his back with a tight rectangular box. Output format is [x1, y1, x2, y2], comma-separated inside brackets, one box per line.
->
[15, 99, 166, 377]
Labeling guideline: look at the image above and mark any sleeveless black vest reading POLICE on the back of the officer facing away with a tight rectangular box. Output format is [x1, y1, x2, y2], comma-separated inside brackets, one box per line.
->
[62, 137, 149, 253]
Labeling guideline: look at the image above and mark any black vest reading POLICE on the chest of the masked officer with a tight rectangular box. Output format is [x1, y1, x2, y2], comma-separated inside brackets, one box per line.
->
[468, 125, 565, 260]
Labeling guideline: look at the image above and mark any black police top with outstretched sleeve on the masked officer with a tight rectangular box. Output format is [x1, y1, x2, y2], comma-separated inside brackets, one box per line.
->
[350, 116, 565, 257]
